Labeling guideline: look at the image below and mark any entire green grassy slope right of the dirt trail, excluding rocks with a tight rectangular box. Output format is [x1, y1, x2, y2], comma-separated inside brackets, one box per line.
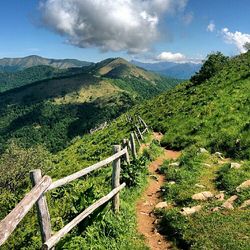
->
[127, 52, 250, 250]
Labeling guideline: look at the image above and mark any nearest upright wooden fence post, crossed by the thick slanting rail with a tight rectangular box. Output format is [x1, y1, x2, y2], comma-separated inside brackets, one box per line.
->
[30, 169, 51, 243]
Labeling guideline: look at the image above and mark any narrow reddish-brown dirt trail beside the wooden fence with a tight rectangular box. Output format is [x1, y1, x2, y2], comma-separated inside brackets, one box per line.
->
[136, 133, 180, 250]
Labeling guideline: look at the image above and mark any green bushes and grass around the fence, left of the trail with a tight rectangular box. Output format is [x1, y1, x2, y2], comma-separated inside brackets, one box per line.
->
[0, 116, 162, 250]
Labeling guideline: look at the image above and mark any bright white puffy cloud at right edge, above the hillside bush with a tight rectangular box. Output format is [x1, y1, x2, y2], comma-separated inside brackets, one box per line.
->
[222, 28, 250, 53]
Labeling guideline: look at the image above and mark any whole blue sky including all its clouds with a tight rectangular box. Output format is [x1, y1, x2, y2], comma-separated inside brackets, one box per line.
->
[0, 0, 250, 63]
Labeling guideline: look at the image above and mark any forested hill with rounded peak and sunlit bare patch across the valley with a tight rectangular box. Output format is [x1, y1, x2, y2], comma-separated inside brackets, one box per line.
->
[0, 58, 180, 152]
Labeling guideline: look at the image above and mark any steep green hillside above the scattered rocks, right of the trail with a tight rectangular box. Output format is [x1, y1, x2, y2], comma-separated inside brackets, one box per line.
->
[132, 52, 250, 159]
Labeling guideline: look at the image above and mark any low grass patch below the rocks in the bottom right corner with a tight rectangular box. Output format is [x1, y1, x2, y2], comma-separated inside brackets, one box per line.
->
[162, 209, 250, 250]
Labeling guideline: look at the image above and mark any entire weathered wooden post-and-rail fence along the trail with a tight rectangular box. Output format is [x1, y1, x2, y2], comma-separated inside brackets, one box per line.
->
[0, 116, 149, 249]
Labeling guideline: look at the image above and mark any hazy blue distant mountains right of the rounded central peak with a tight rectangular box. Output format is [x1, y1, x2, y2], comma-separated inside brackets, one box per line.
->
[131, 60, 202, 79]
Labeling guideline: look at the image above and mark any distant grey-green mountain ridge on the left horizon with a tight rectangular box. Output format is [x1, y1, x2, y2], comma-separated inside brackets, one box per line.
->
[0, 55, 92, 72]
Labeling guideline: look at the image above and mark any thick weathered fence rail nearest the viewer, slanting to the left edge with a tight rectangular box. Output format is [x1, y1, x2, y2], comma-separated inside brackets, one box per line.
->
[0, 176, 52, 246]
